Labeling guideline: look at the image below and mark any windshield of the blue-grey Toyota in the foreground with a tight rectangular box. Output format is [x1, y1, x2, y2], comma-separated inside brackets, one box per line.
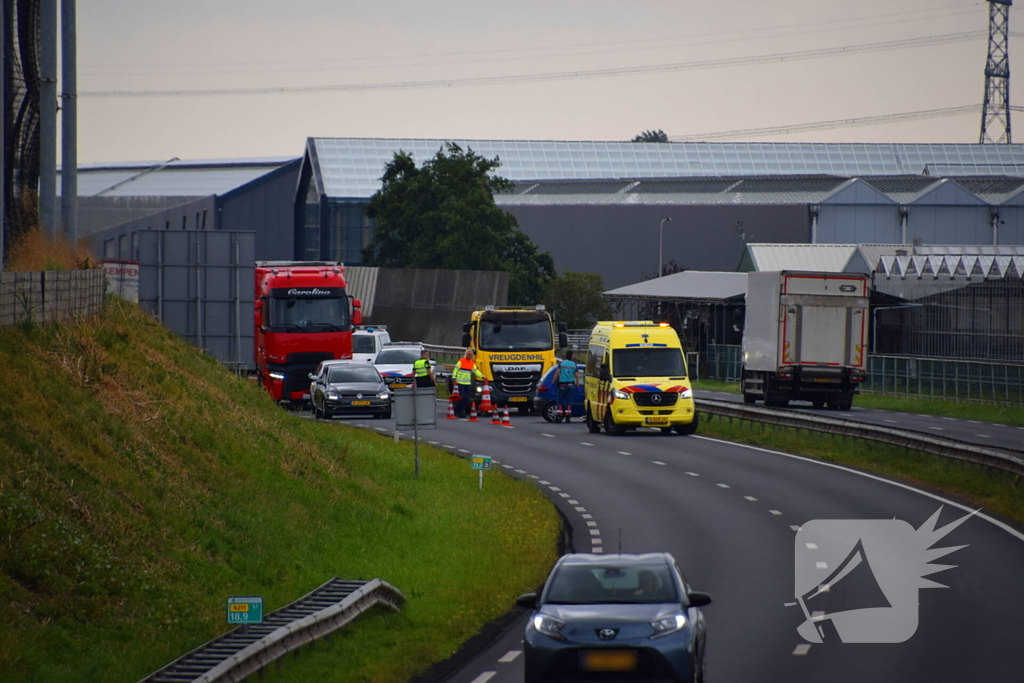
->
[545, 565, 679, 604]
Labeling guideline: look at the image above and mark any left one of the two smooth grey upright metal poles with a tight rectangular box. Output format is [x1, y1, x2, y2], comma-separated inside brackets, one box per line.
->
[39, 0, 57, 240]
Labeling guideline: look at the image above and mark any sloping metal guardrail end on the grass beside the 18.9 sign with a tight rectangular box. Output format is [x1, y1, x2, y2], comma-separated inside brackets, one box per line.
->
[139, 579, 406, 683]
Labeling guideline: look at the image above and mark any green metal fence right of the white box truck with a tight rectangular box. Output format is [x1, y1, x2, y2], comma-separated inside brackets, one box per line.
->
[861, 355, 1024, 404]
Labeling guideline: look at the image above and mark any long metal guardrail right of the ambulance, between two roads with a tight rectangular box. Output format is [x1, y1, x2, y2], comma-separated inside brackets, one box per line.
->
[696, 398, 1024, 476]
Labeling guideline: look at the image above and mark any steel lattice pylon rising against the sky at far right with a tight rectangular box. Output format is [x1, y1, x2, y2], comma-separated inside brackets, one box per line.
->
[980, 0, 1014, 144]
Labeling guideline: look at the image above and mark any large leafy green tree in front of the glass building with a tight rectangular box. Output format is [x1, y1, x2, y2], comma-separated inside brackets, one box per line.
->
[364, 142, 555, 305]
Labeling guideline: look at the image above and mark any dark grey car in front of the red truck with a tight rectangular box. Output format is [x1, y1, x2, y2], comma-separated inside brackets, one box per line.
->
[309, 360, 391, 419]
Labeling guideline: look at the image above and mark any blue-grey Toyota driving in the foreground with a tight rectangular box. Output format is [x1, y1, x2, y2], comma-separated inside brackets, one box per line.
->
[518, 553, 711, 683]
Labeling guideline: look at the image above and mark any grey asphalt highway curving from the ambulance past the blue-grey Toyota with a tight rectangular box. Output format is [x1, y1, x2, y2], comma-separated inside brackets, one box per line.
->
[339, 403, 1024, 683]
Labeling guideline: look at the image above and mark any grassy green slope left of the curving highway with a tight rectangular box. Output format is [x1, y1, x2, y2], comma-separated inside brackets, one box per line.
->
[0, 302, 558, 682]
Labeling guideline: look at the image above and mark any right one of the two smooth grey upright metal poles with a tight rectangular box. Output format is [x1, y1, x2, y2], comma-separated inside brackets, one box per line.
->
[60, 0, 78, 248]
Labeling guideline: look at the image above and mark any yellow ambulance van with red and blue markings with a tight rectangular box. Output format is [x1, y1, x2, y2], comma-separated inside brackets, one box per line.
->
[586, 321, 698, 435]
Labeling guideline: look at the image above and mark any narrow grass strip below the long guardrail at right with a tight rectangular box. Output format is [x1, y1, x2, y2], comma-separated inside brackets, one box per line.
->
[698, 414, 1024, 524]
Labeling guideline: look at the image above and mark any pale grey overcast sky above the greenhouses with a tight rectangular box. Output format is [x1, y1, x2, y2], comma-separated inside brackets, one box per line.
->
[72, 0, 1024, 164]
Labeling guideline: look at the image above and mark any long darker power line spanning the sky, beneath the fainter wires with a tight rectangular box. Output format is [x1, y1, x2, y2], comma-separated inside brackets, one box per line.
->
[79, 31, 987, 97]
